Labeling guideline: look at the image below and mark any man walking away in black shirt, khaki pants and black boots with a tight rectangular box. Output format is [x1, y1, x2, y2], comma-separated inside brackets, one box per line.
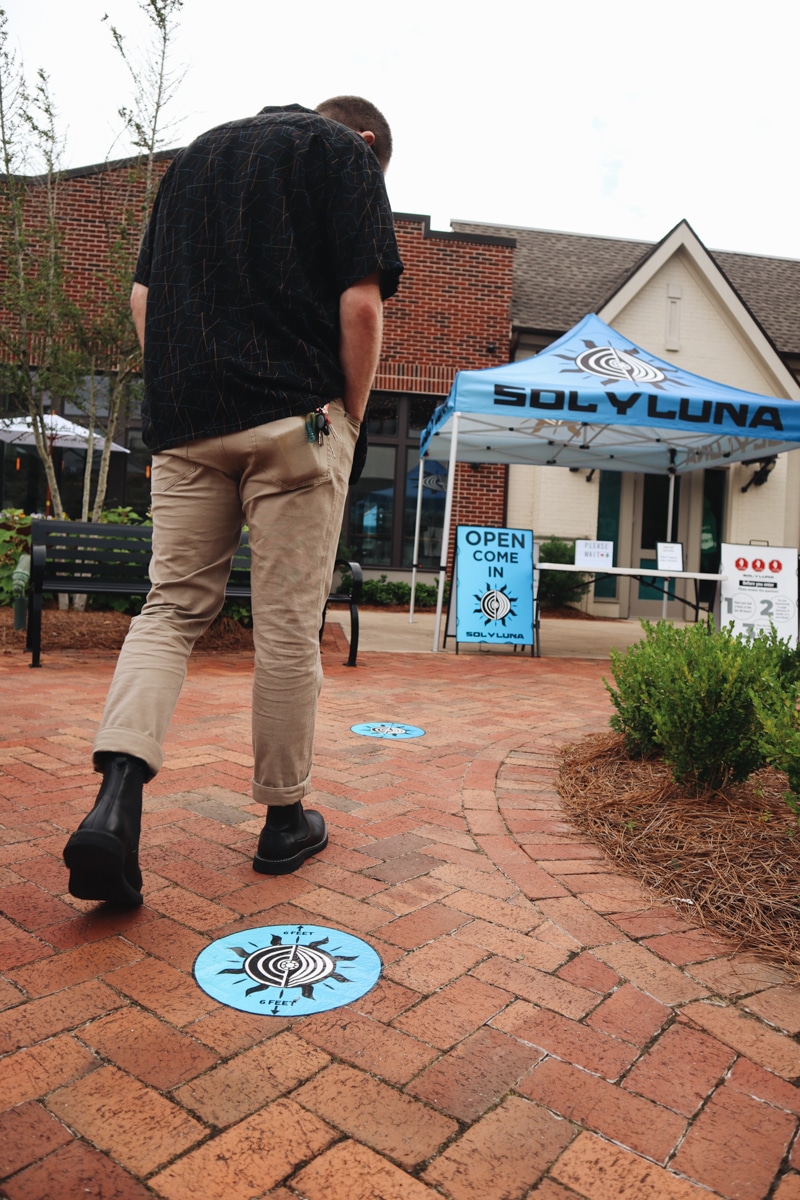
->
[64, 96, 403, 905]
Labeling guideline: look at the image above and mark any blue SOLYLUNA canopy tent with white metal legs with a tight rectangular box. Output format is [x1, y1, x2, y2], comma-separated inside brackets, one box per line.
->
[411, 313, 800, 649]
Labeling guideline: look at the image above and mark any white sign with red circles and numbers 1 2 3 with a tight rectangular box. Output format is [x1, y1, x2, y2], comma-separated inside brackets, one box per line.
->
[718, 542, 798, 647]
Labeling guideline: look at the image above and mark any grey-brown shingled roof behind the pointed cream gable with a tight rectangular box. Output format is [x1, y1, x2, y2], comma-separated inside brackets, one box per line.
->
[452, 221, 800, 355]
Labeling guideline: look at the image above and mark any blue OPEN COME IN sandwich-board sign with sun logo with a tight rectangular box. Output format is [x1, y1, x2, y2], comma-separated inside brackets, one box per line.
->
[456, 526, 534, 646]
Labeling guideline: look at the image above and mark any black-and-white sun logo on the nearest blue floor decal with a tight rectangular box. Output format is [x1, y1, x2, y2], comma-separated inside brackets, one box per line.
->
[217, 925, 356, 1016]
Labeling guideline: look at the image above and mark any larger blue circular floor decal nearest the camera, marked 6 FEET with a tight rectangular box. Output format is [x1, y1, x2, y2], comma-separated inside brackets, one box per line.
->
[194, 925, 380, 1016]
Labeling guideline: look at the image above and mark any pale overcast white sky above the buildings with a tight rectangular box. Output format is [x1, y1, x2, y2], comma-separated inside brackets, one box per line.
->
[0, 0, 800, 258]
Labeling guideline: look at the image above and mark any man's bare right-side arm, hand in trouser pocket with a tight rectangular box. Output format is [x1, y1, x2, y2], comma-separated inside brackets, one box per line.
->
[339, 271, 384, 421]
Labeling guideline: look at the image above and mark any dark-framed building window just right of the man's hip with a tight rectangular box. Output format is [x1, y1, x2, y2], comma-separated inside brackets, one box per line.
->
[342, 392, 447, 568]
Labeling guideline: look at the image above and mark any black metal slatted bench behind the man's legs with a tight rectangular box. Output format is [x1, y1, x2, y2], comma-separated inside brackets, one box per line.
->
[25, 521, 362, 667]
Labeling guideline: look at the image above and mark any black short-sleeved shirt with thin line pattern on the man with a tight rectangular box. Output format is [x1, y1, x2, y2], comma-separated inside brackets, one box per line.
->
[134, 104, 403, 451]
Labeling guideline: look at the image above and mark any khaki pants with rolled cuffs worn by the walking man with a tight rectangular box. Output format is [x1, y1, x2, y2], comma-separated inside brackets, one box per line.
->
[95, 401, 359, 805]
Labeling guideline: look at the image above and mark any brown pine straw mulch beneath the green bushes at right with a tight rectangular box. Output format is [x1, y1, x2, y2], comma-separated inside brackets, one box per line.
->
[560, 733, 800, 973]
